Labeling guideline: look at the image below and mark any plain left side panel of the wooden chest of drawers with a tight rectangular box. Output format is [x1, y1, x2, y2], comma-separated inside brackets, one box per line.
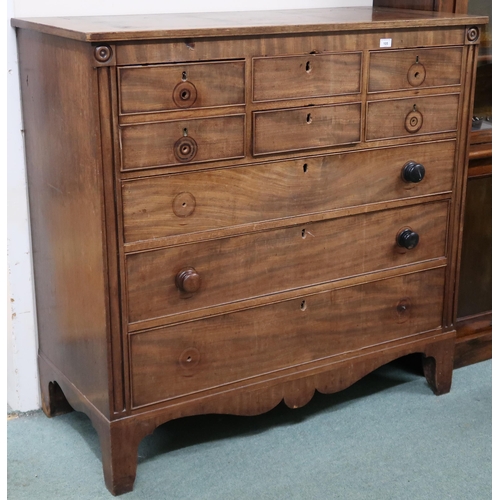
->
[18, 30, 110, 416]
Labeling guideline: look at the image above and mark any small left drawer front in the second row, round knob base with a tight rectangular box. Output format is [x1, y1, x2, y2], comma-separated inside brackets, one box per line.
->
[120, 114, 245, 170]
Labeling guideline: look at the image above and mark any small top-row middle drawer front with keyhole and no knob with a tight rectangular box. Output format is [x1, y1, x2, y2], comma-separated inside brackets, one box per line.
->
[253, 52, 361, 101]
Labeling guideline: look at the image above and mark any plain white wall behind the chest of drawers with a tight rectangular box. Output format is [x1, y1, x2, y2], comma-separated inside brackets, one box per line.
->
[7, 0, 372, 411]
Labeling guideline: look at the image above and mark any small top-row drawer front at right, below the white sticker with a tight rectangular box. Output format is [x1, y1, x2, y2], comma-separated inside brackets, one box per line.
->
[368, 47, 463, 92]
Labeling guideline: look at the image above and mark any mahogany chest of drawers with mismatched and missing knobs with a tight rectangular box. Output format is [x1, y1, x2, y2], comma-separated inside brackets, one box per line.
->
[13, 8, 485, 494]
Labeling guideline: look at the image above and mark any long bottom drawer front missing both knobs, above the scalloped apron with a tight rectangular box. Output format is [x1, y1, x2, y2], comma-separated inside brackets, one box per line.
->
[130, 269, 444, 407]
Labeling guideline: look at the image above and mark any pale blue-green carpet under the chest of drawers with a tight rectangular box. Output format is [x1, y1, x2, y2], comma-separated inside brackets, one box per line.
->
[7, 360, 492, 500]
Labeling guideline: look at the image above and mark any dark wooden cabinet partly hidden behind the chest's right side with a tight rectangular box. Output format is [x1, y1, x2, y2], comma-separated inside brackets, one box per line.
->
[373, 0, 492, 368]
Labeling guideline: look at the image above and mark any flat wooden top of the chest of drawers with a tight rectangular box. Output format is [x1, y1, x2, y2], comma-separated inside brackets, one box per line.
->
[11, 7, 487, 42]
